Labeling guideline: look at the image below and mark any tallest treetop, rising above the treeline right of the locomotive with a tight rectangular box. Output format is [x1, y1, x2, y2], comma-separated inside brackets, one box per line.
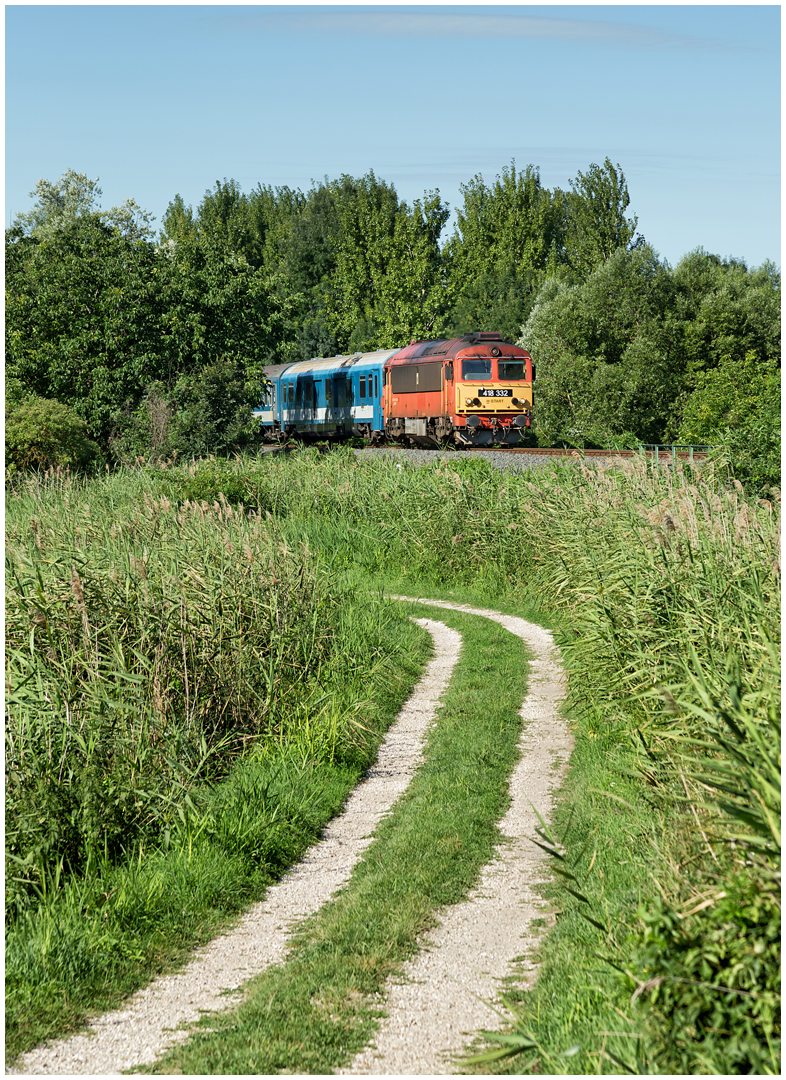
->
[566, 158, 645, 278]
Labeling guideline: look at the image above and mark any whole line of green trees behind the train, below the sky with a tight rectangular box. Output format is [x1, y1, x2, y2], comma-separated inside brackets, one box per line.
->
[5, 158, 780, 490]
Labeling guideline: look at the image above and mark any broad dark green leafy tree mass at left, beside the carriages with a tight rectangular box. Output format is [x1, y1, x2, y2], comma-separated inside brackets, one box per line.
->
[5, 214, 297, 448]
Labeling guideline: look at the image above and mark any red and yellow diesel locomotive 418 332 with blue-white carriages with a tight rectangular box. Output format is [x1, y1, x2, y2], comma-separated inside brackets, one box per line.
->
[254, 330, 534, 446]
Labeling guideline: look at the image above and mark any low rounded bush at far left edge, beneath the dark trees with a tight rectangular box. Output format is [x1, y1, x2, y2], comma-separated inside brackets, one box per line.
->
[5, 393, 99, 472]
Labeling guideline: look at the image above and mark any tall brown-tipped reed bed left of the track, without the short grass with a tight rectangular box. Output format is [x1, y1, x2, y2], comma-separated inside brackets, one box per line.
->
[5, 468, 369, 913]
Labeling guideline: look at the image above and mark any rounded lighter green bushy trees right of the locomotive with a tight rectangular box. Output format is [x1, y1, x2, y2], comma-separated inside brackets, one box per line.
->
[520, 245, 780, 451]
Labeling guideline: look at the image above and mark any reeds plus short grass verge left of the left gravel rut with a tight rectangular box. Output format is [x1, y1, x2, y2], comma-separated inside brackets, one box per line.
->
[5, 462, 422, 1054]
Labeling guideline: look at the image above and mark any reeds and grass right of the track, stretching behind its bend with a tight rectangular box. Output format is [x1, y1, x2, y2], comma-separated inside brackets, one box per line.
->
[157, 453, 780, 1074]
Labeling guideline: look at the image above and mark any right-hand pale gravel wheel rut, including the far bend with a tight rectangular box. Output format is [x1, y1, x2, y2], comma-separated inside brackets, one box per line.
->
[341, 596, 572, 1076]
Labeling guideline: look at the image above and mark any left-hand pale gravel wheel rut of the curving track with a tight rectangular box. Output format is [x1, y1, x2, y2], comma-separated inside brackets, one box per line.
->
[8, 619, 461, 1076]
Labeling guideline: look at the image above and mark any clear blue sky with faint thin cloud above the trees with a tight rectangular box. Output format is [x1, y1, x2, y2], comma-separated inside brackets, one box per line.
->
[4, 4, 781, 266]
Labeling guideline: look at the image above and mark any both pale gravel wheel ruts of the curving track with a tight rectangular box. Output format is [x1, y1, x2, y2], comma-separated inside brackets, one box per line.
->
[9, 597, 572, 1076]
